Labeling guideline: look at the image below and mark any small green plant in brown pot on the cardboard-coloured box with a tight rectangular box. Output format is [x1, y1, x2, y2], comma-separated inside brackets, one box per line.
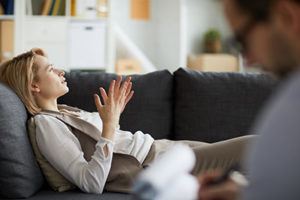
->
[204, 29, 222, 53]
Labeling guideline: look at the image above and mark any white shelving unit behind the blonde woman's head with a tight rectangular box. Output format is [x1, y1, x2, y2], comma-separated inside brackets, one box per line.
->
[0, 0, 115, 72]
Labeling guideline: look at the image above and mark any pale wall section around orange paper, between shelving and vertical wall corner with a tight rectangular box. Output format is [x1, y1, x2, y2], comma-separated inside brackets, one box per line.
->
[113, 0, 182, 71]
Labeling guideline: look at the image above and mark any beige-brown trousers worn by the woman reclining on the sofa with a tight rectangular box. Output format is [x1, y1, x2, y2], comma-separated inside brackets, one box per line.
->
[105, 136, 254, 193]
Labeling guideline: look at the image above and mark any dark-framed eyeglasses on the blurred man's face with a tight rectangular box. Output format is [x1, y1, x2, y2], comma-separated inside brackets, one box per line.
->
[229, 20, 259, 53]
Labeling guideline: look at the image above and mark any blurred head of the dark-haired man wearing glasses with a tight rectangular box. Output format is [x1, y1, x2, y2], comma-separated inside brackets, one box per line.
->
[224, 0, 300, 76]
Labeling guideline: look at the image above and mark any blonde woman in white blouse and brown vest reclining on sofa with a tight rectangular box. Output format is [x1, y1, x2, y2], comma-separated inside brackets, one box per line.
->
[0, 48, 252, 193]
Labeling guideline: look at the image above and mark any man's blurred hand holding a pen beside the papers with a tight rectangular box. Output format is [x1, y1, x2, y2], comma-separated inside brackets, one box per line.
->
[198, 171, 241, 200]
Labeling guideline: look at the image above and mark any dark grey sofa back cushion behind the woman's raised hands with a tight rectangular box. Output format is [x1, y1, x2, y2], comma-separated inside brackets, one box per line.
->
[58, 70, 173, 139]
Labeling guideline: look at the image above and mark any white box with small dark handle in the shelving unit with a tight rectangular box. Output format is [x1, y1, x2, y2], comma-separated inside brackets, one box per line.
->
[68, 20, 107, 69]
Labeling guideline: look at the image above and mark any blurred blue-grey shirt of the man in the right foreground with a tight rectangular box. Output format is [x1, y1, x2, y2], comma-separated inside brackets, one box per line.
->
[245, 69, 300, 200]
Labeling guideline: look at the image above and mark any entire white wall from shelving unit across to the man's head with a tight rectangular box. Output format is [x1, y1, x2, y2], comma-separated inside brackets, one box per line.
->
[113, 0, 230, 72]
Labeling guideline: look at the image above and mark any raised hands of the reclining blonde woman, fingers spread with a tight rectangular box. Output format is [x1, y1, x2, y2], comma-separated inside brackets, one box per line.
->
[94, 77, 133, 139]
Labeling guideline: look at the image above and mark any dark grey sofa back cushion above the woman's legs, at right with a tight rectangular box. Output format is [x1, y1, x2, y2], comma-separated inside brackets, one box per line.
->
[174, 69, 275, 142]
